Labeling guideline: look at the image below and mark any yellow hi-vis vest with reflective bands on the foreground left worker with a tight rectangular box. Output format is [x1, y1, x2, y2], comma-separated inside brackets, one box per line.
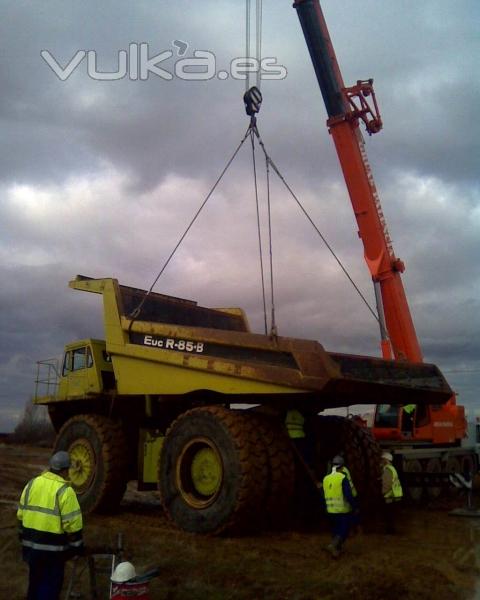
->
[17, 471, 83, 552]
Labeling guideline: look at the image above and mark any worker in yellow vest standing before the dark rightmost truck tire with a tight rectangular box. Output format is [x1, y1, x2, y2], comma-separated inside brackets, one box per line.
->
[323, 456, 357, 558]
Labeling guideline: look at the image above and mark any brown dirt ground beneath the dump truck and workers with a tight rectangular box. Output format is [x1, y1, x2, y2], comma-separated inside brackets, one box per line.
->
[0, 444, 480, 600]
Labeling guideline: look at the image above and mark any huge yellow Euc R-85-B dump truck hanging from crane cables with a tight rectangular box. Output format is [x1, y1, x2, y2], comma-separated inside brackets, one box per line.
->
[35, 276, 452, 533]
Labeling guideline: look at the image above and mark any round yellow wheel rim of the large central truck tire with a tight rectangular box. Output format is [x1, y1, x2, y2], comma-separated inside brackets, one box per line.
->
[176, 438, 223, 508]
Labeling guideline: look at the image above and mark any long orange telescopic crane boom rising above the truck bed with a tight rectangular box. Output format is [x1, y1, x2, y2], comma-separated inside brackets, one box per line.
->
[293, 0, 423, 362]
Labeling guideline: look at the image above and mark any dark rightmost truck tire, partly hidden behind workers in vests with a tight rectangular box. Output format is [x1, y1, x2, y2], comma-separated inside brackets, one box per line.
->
[312, 415, 381, 510]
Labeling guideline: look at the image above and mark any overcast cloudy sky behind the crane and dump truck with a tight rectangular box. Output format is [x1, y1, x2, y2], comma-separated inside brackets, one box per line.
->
[0, 0, 480, 431]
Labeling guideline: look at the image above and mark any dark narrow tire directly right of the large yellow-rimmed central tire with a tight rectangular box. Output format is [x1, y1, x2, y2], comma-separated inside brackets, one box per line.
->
[249, 414, 295, 529]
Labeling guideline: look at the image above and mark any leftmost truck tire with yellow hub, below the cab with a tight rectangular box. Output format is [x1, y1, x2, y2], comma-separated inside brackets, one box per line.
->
[55, 414, 127, 513]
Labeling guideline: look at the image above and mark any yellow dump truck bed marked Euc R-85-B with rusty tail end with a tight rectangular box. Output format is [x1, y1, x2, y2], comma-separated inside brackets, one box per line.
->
[70, 276, 452, 410]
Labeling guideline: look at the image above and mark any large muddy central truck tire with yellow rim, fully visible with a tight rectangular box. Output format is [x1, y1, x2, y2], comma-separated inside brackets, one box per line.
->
[158, 406, 267, 534]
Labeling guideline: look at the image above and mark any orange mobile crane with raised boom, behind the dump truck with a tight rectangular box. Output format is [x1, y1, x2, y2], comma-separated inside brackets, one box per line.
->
[294, 0, 478, 498]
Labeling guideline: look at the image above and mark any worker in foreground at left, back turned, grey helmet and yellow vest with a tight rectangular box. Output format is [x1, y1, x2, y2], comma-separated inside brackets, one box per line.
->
[17, 450, 83, 600]
